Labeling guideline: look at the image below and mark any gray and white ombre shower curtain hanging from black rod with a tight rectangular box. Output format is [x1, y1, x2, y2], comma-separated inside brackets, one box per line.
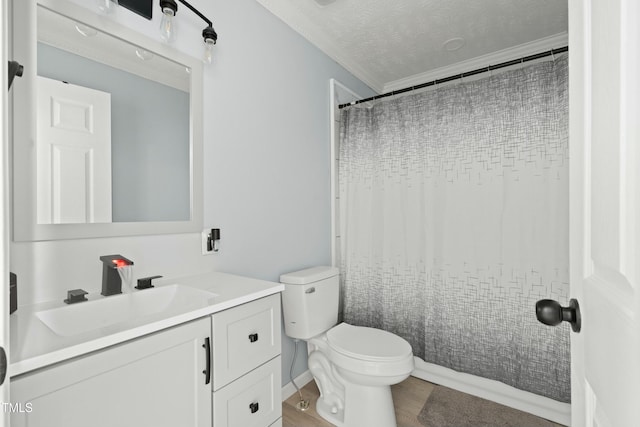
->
[339, 56, 570, 402]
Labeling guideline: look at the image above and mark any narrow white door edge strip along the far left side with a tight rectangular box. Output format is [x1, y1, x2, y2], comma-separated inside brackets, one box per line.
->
[0, 1, 10, 427]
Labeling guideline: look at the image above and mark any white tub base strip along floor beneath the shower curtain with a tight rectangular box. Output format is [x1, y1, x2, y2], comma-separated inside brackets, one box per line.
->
[412, 357, 571, 426]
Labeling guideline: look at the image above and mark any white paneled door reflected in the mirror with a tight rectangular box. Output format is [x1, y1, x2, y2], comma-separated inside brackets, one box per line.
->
[36, 77, 111, 224]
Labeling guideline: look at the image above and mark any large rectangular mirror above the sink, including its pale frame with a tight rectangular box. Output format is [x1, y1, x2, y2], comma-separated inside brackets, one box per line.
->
[13, 0, 202, 241]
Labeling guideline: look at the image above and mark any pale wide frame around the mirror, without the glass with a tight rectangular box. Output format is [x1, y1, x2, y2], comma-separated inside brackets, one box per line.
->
[11, 0, 203, 242]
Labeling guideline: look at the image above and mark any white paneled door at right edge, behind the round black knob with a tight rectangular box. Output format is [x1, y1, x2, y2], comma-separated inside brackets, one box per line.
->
[569, 0, 640, 427]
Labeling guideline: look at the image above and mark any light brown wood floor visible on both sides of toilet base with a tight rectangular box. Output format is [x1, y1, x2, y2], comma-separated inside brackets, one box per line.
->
[282, 377, 560, 427]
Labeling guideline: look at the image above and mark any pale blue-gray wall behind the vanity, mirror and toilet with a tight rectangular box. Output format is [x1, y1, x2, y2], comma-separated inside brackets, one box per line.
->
[11, 0, 373, 384]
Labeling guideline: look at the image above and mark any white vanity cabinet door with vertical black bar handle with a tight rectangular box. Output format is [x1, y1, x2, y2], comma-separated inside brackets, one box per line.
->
[10, 318, 212, 427]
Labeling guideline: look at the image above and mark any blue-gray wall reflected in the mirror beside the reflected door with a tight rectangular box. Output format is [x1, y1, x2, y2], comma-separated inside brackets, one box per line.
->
[38, 43, 190, 222]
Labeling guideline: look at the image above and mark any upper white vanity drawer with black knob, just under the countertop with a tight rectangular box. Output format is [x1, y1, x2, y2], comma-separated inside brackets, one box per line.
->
[211, 294, 281, 390]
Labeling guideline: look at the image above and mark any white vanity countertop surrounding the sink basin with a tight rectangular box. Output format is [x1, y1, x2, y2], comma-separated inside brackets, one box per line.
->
[9, 272, 284, 377]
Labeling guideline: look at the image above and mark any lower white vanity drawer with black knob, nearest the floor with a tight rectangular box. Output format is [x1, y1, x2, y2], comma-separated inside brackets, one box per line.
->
[213, 356, 282, 427]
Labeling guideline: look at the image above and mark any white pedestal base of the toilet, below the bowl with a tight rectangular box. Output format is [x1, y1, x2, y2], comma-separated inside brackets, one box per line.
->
[316, 383, 397, 427]
